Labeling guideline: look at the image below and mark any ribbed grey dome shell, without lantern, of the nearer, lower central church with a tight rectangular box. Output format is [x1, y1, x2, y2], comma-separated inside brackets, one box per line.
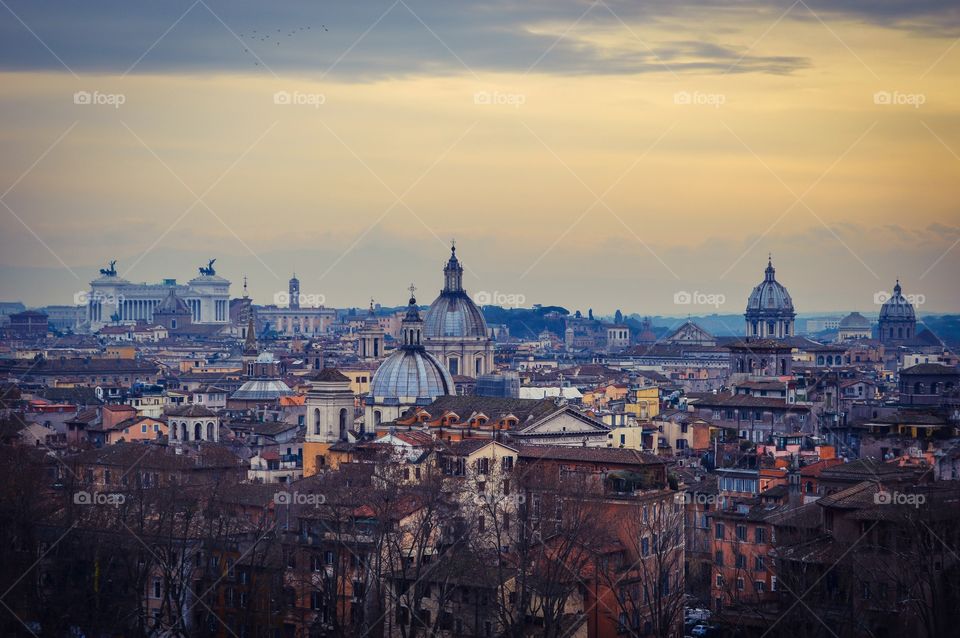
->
[369, 347, 454, 404]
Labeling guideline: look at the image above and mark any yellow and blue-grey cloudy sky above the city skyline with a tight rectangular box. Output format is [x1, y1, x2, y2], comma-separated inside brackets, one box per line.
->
[0, 0, 960, 315]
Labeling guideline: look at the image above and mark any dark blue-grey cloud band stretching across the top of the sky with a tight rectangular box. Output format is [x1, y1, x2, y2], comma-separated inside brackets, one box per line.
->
[0, 0, 960, 81]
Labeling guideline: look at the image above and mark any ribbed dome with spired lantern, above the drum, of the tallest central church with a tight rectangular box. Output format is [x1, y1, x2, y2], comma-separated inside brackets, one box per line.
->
[423, 247, 487, 339]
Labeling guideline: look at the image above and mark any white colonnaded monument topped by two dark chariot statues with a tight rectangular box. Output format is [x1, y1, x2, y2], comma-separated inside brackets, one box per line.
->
[86, 260, 230, 332]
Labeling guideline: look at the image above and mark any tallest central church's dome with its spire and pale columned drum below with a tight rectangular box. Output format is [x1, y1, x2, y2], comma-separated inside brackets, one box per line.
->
[423, 246, 493, 377]
